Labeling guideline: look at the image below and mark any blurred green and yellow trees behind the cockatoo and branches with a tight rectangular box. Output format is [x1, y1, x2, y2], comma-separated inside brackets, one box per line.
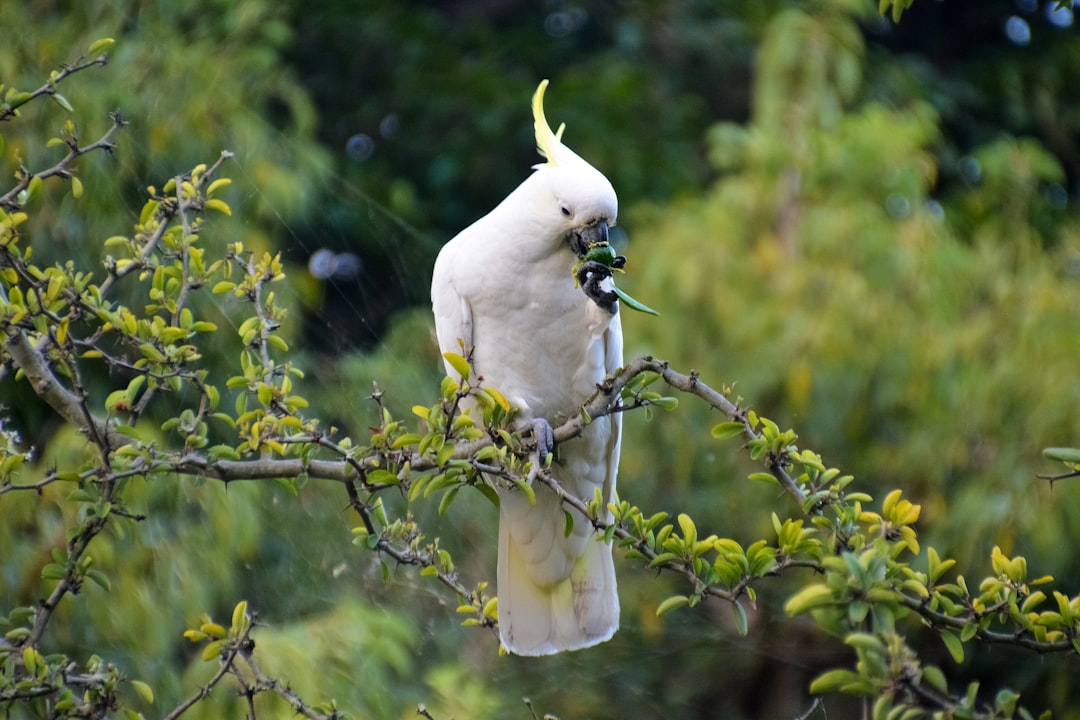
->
[0, 0, 1080, 719]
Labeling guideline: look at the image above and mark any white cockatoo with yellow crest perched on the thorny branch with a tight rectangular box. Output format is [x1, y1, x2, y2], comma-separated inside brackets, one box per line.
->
[431, 80, 622, 655]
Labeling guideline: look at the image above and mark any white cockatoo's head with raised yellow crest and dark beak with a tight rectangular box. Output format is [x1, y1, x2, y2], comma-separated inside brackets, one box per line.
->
[531, 80, 619, 258]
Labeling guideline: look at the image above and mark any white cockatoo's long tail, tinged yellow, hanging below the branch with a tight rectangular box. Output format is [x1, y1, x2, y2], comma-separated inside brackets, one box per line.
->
[497, 496, 619, 655]
